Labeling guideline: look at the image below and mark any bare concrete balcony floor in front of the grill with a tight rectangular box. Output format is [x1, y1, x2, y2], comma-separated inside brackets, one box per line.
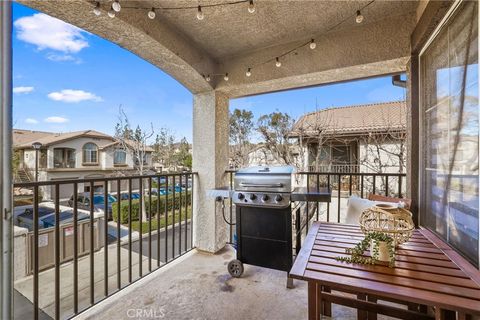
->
[76, 246, 400, 320]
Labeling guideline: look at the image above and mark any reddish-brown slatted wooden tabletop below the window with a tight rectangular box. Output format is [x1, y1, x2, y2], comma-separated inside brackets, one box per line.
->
[291, 222, 480, 316]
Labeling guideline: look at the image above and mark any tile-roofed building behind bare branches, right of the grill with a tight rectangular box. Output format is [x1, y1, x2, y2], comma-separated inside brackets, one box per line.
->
[292, 101, 407, 173]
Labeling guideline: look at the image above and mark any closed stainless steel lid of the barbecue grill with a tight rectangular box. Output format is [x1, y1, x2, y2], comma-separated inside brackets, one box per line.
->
[234, 166, 295, 192]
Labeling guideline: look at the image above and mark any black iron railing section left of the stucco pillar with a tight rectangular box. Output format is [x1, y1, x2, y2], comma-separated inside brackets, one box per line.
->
[14, 172, 196, 319]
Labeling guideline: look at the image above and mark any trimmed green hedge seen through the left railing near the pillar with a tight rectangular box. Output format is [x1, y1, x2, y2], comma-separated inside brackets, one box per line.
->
[112, 191, 192, 223]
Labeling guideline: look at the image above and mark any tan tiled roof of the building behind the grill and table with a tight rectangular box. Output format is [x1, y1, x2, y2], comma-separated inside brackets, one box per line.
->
[291, 101, 407, 137]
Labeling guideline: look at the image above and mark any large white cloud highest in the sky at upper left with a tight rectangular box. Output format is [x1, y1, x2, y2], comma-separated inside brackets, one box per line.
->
[14, 13, 88, 53]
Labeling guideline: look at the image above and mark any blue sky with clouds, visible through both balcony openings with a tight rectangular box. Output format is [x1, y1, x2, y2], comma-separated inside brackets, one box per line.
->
[13, 3, 405, 141]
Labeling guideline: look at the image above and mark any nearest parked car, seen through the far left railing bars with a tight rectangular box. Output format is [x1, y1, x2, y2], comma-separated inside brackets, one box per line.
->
[14, 202, 90, 231]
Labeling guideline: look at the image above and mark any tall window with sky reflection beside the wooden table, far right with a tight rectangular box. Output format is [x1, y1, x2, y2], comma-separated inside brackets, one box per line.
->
[420, 1, 480, 266]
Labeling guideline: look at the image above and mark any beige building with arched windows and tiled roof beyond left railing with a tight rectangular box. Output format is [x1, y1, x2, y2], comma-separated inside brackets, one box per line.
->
[13, 129, 153, 199]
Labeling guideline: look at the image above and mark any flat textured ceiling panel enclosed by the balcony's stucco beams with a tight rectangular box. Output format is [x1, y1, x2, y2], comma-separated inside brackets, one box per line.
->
[123, 0, 418, 60]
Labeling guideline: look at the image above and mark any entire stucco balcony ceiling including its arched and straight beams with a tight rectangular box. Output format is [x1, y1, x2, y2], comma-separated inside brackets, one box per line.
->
[18, 0, 418, 97]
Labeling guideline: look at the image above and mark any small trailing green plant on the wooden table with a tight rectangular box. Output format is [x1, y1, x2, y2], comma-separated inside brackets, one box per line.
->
[335, 232, 395, 268]
